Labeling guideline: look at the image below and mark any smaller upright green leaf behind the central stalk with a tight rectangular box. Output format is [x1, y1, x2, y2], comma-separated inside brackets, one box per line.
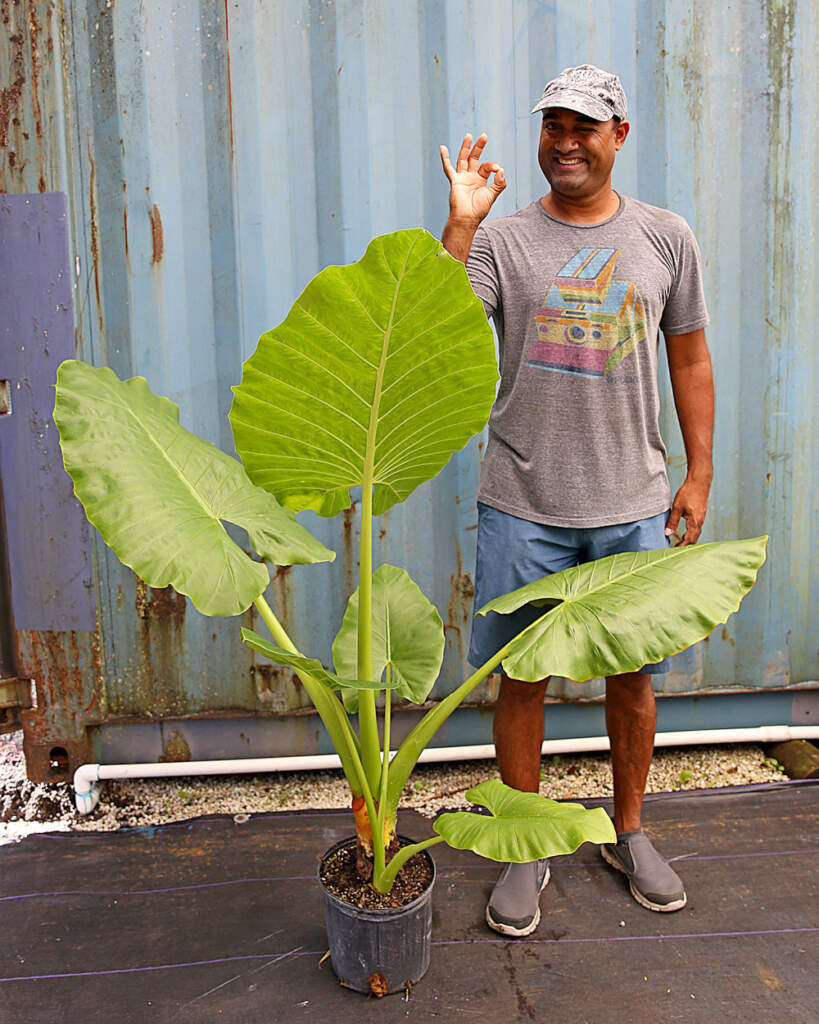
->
[333, 565, 446, 711]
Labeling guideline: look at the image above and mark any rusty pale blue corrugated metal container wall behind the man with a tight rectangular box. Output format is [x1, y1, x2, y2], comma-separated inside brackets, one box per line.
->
[0, 0, 819, 770]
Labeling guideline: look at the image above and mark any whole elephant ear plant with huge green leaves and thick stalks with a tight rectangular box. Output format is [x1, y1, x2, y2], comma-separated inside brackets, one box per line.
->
[54, 230, 767, 893]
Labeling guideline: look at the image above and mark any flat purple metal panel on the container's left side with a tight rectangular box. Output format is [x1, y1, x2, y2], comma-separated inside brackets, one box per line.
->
[0, 193, 96, 632]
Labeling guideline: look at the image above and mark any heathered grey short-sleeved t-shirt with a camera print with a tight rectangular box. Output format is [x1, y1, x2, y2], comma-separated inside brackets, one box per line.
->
[467, 197, 708, 527]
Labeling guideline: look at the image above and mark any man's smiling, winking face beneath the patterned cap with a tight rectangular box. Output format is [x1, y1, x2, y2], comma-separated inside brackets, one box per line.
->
[537, 106, 629, 199]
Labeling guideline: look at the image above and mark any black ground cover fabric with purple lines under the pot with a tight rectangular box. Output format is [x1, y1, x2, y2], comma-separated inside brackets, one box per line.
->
[0, 783, 819, 1024]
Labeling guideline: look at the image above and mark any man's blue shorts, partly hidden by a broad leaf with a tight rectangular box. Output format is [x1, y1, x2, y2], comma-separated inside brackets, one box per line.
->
[469, 502, 671, 675]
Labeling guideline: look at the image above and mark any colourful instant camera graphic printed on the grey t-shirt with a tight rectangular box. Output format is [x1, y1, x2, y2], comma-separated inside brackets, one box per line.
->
[526, 249, 646, 377]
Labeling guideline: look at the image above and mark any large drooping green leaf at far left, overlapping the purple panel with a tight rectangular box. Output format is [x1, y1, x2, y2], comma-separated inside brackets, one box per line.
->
[54, 359, 336, 615]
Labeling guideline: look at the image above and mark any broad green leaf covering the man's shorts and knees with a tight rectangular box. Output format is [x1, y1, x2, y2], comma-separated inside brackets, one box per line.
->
[477, 537, 768, 681]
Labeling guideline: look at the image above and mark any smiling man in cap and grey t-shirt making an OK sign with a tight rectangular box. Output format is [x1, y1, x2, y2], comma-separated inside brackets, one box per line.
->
[441, 65, 714, 936]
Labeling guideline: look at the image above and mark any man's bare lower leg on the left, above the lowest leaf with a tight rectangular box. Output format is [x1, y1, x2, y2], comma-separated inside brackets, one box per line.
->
[493, 676, 549, 793]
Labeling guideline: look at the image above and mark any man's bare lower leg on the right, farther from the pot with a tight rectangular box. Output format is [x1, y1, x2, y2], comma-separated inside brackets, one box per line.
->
[606, 672, 657, 833]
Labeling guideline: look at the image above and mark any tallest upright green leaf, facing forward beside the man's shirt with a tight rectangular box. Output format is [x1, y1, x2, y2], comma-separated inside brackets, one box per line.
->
[230, 229, 498, 516]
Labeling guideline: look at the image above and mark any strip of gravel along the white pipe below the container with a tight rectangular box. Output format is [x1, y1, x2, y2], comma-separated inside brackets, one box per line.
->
[0, 733, 783, 844]
